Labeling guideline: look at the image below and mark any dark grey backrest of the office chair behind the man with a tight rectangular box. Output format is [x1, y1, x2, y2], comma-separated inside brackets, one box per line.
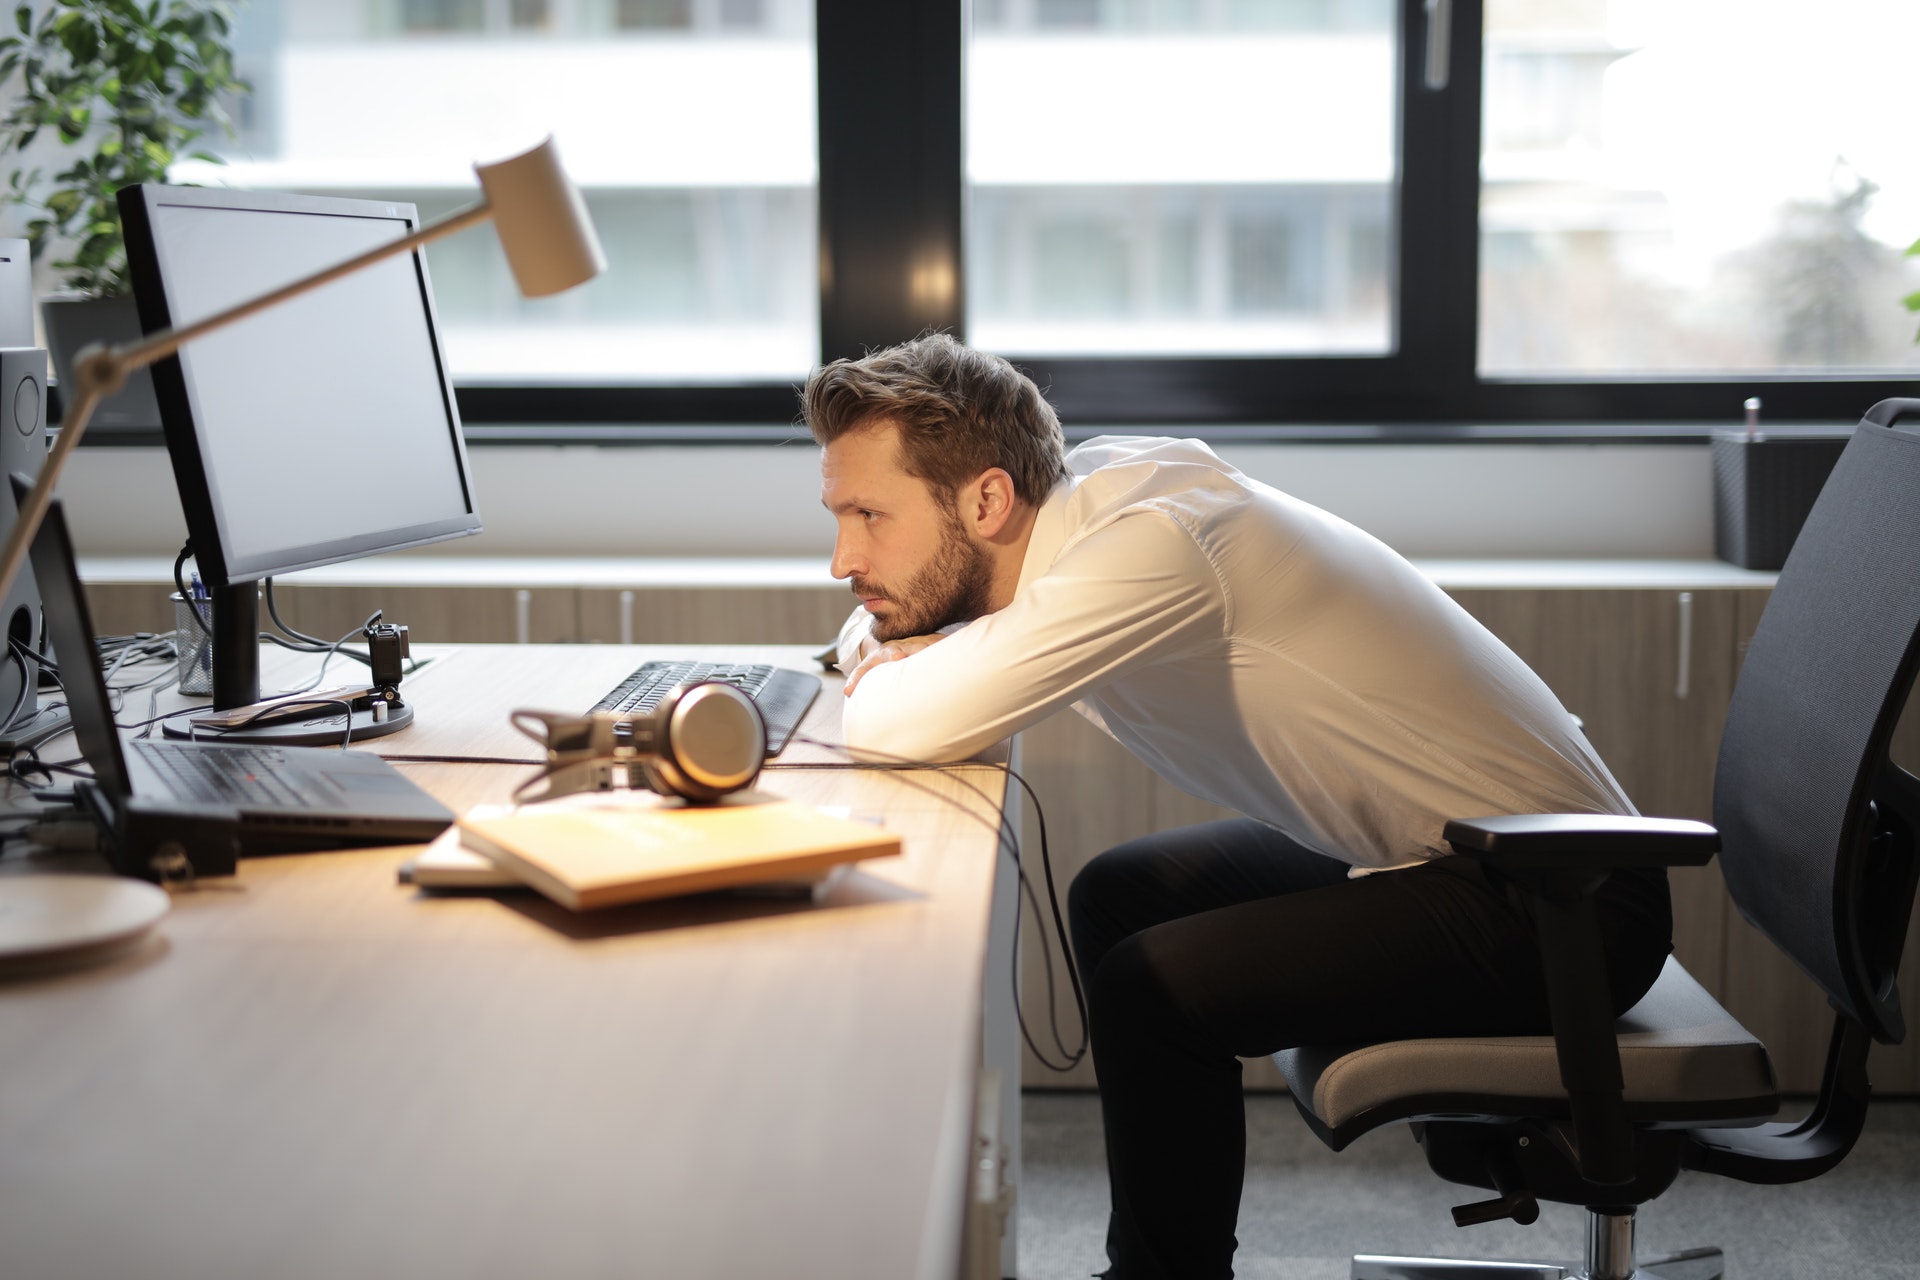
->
[1713, 399, 1920, 1040]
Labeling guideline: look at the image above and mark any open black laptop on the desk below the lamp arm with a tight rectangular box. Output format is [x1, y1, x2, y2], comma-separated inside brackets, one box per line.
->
[13, 485, 453, 862]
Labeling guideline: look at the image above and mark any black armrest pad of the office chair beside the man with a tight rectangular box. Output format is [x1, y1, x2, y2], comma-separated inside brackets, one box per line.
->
[1444, 814, 1720, 873]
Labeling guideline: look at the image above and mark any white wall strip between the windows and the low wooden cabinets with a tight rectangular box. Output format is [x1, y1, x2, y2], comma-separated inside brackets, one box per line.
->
[60, 443, 1713, 558]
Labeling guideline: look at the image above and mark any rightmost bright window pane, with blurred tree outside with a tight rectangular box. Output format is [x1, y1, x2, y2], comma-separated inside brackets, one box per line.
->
[1478, 0, 1920, 379]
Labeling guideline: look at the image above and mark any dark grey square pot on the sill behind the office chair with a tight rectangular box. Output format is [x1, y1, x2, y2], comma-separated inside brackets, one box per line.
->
[1713, 426, 1853, 570]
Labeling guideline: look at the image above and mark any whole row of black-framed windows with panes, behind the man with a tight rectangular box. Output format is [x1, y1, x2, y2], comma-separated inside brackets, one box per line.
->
[22, 0, 1920, 439]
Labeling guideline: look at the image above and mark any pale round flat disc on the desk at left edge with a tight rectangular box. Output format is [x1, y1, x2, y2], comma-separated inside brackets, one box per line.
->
[0, 875, 171, 973]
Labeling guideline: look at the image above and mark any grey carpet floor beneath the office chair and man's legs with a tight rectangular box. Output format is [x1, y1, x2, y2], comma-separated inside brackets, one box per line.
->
[1020, 1092, 1920, 1280]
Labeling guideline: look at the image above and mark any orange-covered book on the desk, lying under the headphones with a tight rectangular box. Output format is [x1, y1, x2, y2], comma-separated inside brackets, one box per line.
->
[459, 800, 900, 912]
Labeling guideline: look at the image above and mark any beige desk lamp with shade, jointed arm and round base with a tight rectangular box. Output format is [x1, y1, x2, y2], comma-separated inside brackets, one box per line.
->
[0, 136, 607, 973]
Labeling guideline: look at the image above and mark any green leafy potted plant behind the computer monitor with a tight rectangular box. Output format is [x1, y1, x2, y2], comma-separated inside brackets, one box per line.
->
[0, 0, 248, 426]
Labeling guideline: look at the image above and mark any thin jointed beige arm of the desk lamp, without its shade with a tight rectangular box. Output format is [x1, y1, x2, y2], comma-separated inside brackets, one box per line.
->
[0, 200, 493, 614]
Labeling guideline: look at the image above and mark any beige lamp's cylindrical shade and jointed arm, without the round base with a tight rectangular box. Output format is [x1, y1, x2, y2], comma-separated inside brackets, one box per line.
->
[0, 136, 607, 621]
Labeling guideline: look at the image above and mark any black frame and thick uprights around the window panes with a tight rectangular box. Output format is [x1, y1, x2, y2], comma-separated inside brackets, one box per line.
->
[82, 0, 1920, 443]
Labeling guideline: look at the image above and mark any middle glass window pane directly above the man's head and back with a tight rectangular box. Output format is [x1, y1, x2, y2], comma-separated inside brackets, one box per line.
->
[966, 0, 1398, 357]
